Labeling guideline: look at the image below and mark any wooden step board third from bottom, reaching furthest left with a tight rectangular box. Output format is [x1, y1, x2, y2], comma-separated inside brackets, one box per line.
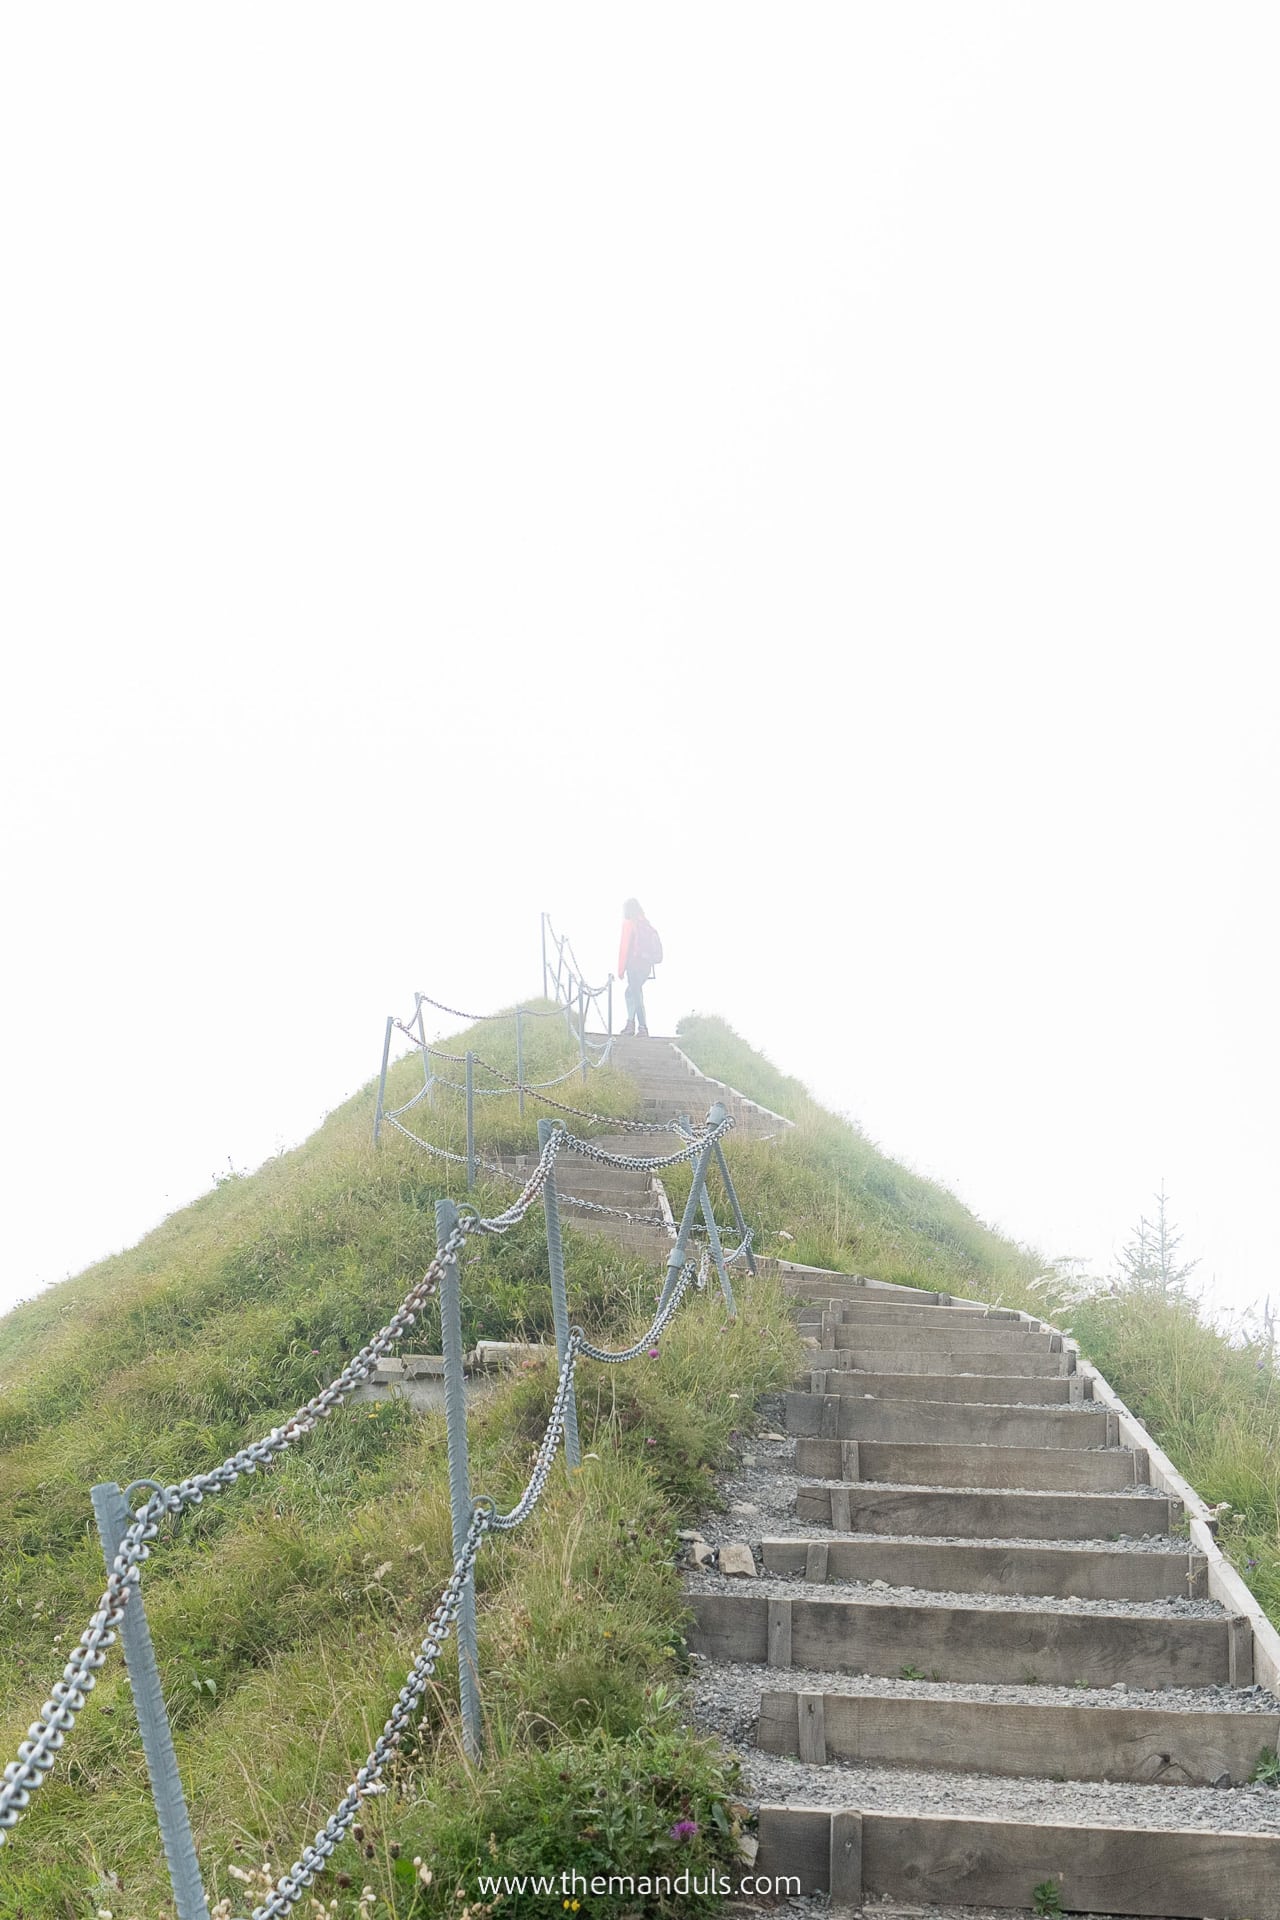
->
[689, 1590, 1253, 1688]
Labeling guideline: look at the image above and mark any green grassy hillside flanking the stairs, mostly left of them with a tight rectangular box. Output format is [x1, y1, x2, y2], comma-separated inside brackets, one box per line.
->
[0, 1020, 1276, 1920]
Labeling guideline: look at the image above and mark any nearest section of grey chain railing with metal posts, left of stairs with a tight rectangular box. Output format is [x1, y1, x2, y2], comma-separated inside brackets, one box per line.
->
[0, 1104, 750, 1920]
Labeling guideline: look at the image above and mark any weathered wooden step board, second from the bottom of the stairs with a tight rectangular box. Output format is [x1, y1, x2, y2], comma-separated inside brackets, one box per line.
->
[756, 1690, 1280, 1786]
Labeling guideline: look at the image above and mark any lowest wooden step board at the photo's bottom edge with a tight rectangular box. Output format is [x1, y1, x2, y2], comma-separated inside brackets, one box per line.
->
[756, 1807, 1280, 1920]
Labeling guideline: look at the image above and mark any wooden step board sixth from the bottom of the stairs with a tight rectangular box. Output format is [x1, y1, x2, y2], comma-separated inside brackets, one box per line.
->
[796, 1436, 1150, 1494]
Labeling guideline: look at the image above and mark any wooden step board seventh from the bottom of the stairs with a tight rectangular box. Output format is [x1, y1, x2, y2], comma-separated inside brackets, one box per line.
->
[785, 1394, 1119, 1452]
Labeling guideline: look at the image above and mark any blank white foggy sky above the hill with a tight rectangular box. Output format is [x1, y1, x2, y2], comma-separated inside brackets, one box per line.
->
[0, 4, 1280, 1306]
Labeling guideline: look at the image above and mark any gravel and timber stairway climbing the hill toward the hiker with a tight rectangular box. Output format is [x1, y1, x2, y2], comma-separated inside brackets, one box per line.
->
[574, 1039, 1280, 1920]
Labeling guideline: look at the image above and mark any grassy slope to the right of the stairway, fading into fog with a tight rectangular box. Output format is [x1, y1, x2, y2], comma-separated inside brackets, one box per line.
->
[679, 1016, 1280, 1624]
